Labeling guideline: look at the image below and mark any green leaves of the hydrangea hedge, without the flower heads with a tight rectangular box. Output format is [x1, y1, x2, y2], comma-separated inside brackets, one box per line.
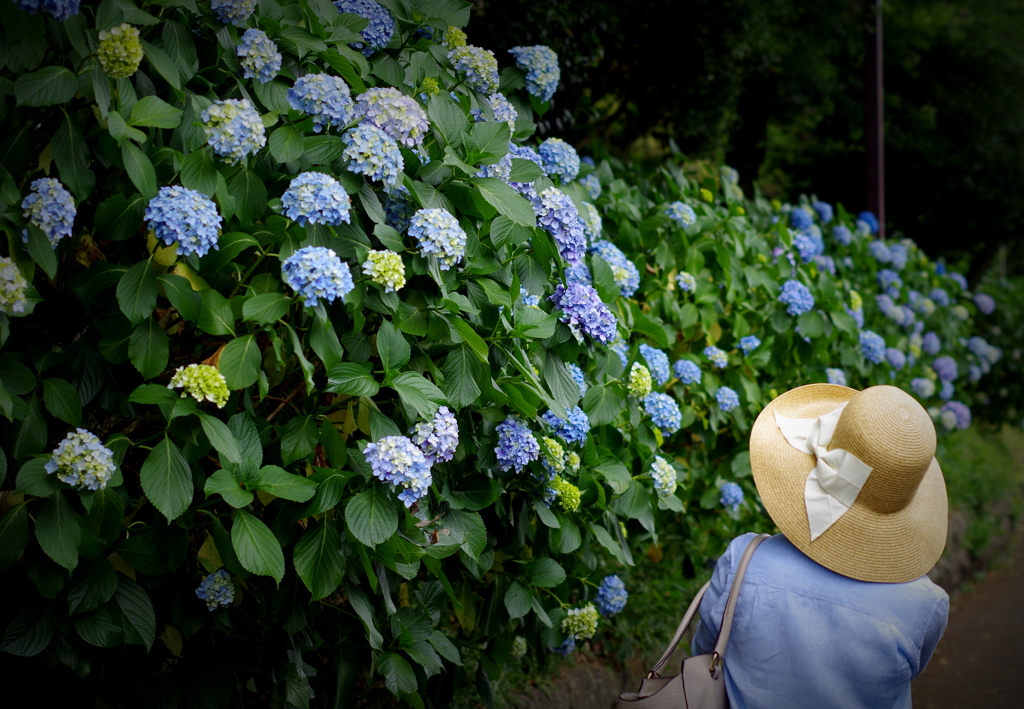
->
[0, 0, 1007, 707]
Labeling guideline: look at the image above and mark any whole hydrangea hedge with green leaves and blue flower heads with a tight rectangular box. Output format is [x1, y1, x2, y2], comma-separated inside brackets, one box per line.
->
[0, 0, 1002, 708]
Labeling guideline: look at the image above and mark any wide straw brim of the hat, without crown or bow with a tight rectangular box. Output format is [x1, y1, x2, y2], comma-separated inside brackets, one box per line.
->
[751, 384, 948, 583]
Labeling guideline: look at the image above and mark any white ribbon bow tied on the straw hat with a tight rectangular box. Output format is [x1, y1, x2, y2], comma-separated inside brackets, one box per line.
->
[775, 402, 871, 542]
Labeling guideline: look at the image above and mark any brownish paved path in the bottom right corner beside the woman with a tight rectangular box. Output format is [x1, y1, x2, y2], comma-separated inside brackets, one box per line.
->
[911, 535, 1024, 709]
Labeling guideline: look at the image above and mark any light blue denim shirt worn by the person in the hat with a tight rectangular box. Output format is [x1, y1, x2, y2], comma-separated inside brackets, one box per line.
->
[692, 534, 949, 709]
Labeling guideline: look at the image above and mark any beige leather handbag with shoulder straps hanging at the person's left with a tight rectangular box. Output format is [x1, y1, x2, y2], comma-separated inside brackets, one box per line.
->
[616, 534, 770, 709]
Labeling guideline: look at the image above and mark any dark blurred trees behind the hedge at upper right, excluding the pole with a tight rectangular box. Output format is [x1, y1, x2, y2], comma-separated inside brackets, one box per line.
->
[467, 0, 1024, 281]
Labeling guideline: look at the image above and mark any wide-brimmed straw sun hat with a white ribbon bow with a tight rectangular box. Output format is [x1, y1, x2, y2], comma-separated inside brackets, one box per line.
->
[751, 384, 947, 583]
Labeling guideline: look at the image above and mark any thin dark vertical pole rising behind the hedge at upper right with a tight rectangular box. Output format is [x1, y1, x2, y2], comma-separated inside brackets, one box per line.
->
[864, 0, 886, 239]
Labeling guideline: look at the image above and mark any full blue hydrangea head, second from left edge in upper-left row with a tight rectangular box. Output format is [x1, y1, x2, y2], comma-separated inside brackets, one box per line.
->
[145, 184, 223, 256]
